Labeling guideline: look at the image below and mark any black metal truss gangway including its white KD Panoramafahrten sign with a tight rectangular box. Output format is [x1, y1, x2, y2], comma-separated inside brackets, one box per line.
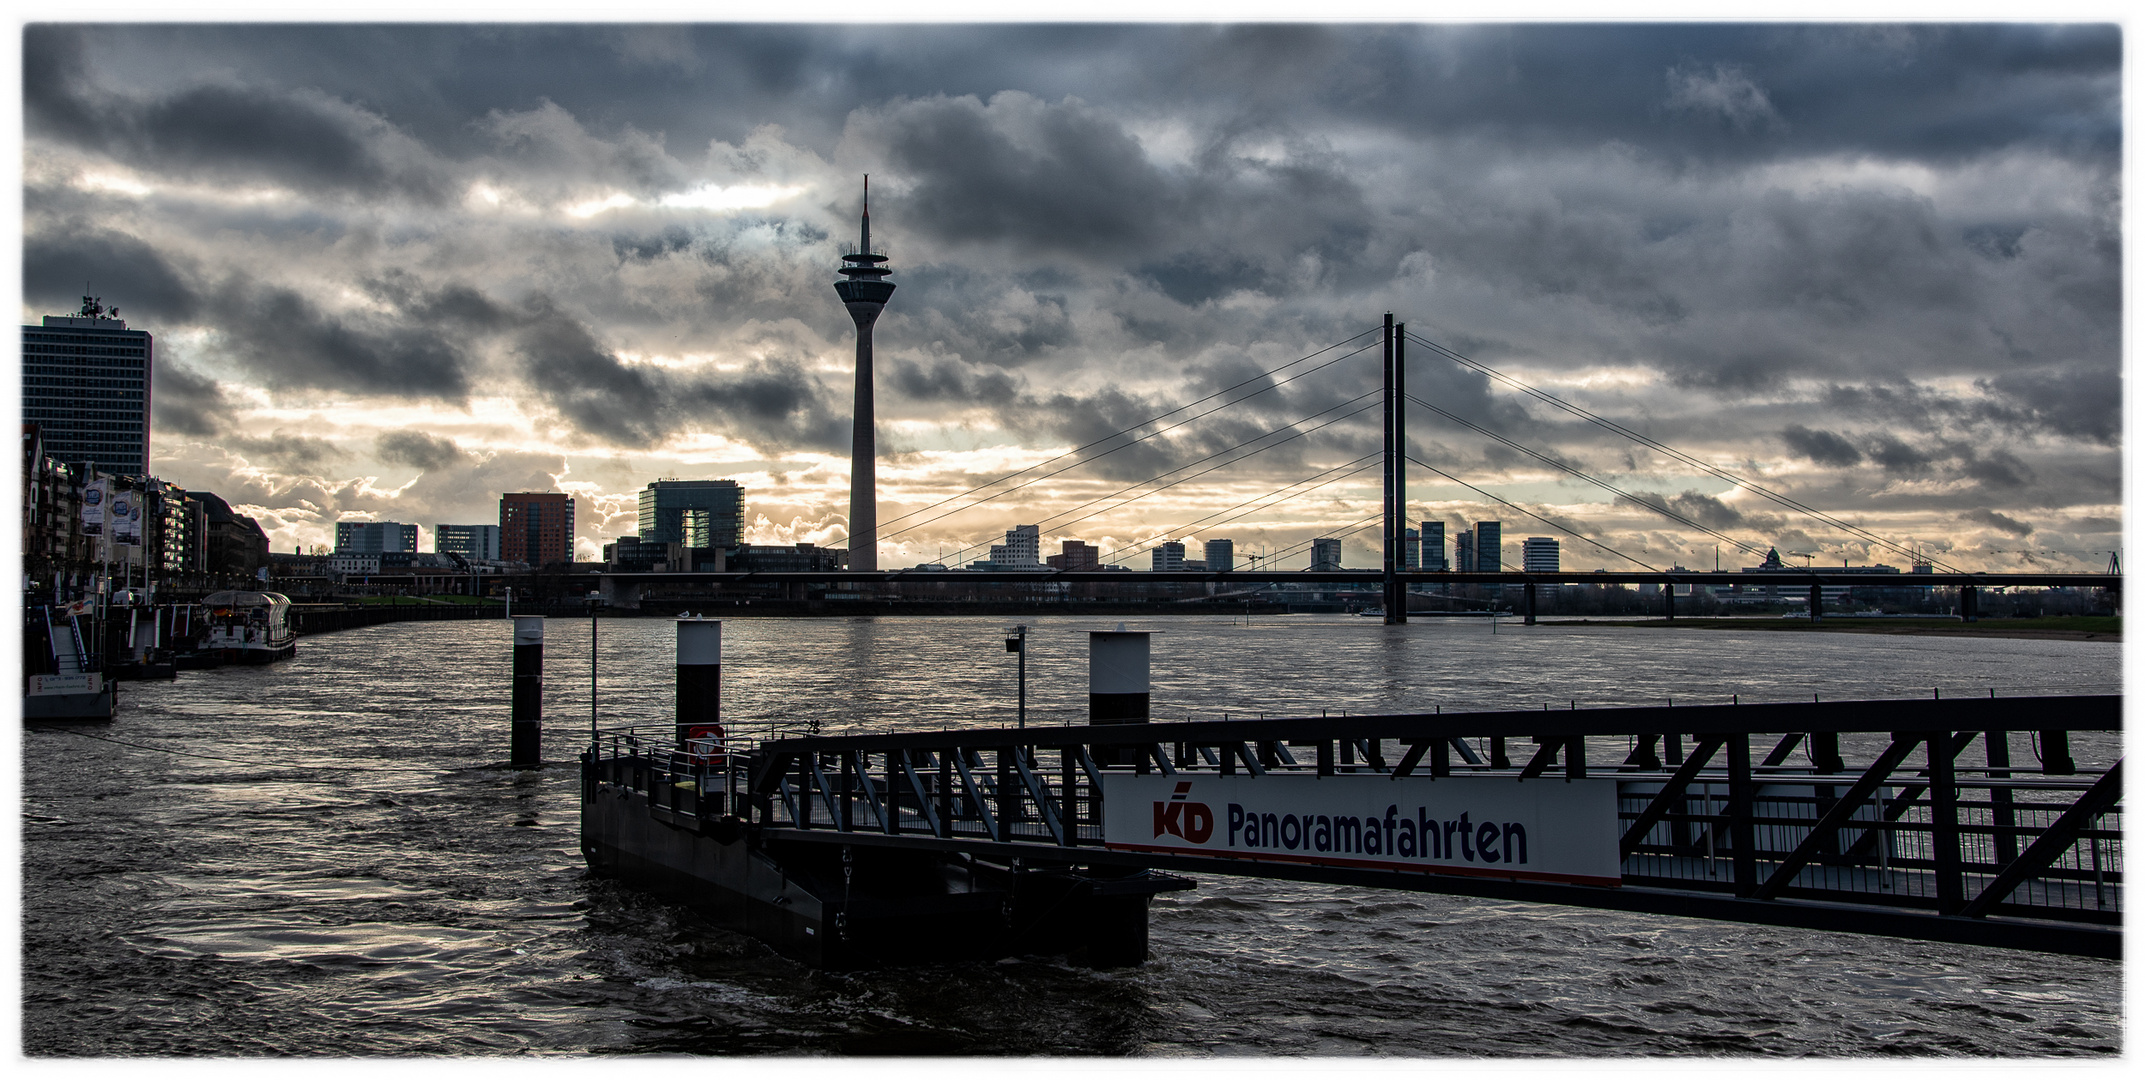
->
[586, 696, 2124, 958]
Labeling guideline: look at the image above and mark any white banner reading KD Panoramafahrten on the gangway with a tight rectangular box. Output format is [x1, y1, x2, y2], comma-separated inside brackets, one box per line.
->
[1103, 773, 1622, 885]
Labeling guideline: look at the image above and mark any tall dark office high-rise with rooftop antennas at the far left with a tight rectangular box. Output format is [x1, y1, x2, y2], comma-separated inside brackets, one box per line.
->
[21, 296, 157, 477]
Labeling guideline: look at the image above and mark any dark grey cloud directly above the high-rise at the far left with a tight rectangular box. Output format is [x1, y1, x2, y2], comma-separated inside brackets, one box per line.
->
[21, 221, 199, 322]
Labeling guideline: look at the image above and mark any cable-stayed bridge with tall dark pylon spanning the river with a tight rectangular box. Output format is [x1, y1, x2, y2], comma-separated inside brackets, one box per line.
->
[605, 316, 2119, 621]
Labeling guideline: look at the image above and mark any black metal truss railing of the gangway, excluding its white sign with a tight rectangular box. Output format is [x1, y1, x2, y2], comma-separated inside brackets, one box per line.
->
[592, 696, 2124, 951]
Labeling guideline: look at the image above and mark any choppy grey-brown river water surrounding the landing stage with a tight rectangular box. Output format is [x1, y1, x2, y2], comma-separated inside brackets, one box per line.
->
[21, 616, 2121, 1056]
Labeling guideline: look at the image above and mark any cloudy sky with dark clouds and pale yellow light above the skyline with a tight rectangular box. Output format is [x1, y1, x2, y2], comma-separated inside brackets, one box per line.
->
[21, 24, 2121, 569]
